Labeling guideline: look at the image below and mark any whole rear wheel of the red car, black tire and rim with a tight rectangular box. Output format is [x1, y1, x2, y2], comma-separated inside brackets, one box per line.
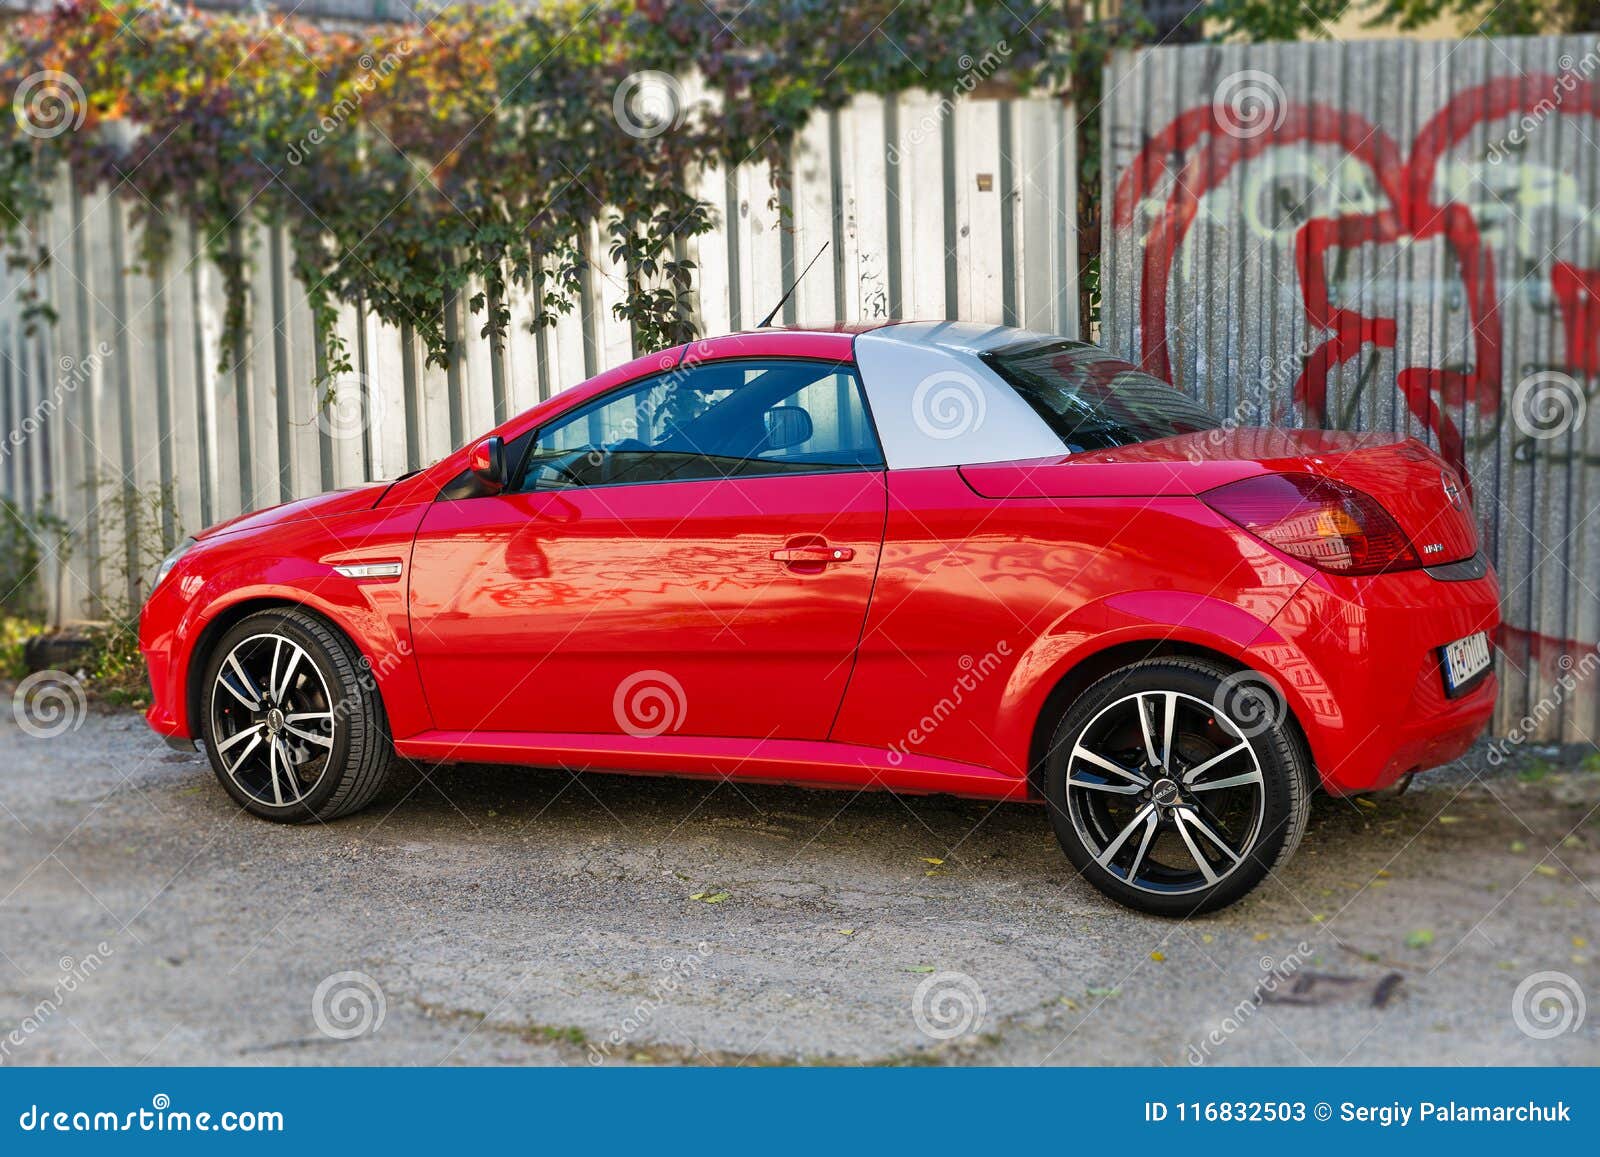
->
[1045, 658, 1314, 917]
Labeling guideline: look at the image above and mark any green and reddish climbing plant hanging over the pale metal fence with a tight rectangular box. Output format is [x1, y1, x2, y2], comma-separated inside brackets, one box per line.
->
[0, 0, 1070, 392]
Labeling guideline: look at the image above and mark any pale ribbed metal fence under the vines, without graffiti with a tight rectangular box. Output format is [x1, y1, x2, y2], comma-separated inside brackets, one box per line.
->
[0, 96, 1078, 621]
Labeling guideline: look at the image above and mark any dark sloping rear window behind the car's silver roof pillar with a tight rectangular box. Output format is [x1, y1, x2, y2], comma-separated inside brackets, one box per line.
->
[981, 341, 1221, 453]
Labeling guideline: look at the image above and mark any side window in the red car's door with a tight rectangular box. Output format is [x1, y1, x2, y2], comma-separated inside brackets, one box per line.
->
[517, 360, 883, 490]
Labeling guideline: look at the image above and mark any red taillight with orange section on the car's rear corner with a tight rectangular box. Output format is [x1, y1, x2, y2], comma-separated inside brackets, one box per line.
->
[1200, 474, 1422, 574]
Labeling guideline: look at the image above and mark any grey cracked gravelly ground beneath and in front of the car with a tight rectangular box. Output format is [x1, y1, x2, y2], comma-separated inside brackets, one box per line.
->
[0, 697, 1600, 1066]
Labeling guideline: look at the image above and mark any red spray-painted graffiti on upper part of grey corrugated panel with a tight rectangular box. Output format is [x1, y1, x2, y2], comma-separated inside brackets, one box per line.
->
[1112, 75, 1600, 477]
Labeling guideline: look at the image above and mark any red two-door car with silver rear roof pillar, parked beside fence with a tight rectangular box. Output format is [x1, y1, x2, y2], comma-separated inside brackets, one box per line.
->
[141, 323, 1499, 915]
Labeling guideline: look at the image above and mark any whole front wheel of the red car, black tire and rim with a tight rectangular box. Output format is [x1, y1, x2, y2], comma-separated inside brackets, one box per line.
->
[200, 608, 394, 824]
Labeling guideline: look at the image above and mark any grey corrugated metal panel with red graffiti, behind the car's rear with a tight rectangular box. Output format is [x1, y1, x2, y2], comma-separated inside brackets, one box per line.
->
[1102, 38, 1600, 741]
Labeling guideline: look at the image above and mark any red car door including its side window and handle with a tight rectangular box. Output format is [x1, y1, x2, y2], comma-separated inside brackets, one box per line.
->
[410, 358, 886, 739]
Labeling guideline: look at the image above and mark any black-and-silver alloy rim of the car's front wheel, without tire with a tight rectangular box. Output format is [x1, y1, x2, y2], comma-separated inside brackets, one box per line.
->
[211, 634, 334, 807]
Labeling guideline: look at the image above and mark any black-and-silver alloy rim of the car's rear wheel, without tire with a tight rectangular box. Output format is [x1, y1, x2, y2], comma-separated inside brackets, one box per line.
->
[1066, 691, 1266, 896]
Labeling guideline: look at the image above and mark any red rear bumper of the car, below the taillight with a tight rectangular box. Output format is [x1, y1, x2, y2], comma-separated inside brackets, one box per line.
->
[1248, 566, 1499, 795]
